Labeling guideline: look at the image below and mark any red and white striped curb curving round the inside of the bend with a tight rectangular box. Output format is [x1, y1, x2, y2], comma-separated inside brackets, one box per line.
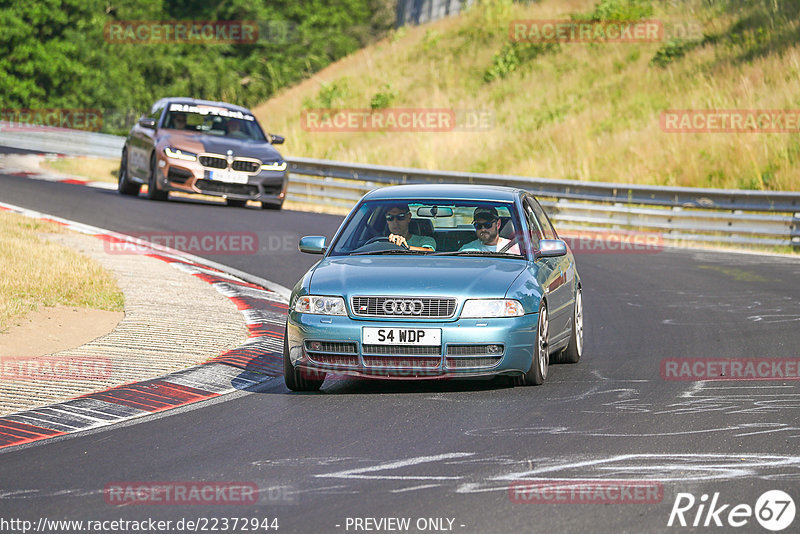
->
[0, 202, 289, 449]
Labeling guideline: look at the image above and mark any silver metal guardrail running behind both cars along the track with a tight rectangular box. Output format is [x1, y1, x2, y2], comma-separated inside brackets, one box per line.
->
[0, 129, 800, 248]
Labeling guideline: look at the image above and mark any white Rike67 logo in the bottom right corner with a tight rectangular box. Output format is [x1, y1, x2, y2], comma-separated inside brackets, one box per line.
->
[667, 490, 796, 532]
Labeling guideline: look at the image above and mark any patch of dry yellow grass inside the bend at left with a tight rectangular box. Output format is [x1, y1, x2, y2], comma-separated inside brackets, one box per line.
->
[0, 212, 124, 332]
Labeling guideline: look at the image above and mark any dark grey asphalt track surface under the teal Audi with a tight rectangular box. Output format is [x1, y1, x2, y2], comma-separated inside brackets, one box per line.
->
[0, 161, 800, 533]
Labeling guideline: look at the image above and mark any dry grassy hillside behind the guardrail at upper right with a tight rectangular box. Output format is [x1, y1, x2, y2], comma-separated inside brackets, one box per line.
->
[254, 0, 800, 190]
